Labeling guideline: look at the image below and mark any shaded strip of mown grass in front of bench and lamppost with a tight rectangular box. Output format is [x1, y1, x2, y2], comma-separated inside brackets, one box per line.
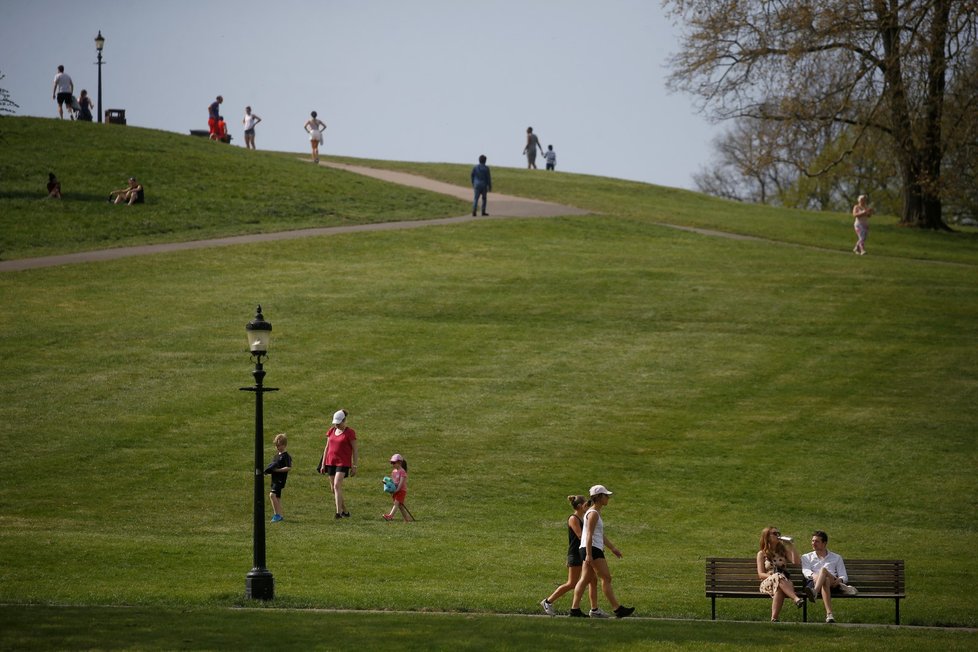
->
[0, 606, 976, 652]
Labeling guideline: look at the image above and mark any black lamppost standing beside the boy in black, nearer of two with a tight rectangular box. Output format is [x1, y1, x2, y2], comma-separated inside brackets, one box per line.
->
[241, 306, 278, 600]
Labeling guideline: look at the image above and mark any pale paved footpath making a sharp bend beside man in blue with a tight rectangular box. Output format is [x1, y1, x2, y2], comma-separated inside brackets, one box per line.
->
[0, 166, 588, 272]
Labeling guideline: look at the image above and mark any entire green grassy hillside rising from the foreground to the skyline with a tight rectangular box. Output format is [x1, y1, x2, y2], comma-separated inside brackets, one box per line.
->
[0, 118, 978, 649]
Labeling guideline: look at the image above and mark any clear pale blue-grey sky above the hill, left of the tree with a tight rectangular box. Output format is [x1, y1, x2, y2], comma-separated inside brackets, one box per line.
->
[0, 0, 719, 188]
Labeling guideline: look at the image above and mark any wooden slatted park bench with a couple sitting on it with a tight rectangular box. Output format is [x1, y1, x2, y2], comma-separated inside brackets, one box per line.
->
[706, 557, 907, 625]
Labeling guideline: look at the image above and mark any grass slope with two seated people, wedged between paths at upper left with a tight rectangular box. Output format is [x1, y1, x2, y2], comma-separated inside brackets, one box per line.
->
[0, 117, 467, 260]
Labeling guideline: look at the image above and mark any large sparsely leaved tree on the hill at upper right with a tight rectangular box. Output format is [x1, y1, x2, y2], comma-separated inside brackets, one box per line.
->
[663, 0, 978, 229]
